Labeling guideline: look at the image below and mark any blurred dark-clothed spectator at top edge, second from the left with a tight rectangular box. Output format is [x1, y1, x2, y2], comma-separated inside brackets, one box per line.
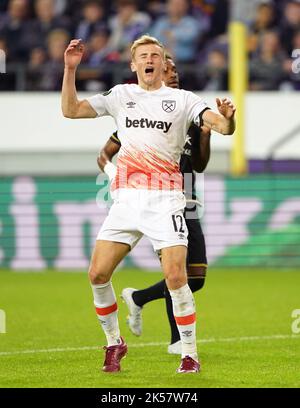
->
[23, 0, 70, 53]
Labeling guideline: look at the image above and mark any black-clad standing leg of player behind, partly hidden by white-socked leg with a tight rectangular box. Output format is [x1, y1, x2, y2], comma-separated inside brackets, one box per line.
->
[165, 219, 207, 354]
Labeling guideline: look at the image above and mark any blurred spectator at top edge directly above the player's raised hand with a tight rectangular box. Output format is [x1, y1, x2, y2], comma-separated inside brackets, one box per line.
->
[75, 0, 107, 42]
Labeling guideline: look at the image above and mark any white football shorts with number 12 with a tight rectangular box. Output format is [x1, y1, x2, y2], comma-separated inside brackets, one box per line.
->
[97, 188, 188, 251]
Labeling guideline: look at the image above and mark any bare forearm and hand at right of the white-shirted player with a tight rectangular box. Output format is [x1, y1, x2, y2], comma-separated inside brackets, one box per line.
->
[202, 98, 236, 135]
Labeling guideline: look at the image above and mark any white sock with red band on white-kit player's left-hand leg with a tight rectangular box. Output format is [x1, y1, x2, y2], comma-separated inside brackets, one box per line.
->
[91, 281, 121, 346]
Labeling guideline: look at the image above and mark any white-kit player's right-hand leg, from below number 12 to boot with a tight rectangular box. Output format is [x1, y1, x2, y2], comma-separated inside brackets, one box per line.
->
[161, 245, 200, 373]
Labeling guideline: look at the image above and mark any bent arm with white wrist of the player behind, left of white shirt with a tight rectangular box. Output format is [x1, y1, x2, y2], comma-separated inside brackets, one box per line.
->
[97, 132, 121, 180]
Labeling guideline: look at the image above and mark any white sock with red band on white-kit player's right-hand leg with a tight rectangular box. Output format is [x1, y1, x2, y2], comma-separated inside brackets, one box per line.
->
[169, 284, 198, 361]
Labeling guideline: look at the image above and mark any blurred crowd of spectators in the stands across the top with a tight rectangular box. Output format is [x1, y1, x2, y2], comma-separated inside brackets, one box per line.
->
[0, 0, 300, 91]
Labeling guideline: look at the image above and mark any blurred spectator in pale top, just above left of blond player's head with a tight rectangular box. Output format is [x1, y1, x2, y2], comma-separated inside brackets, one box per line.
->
[109, 0, 150, 61]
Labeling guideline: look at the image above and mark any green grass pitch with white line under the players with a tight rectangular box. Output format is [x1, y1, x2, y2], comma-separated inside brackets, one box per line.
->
[0, 269, 300, 388]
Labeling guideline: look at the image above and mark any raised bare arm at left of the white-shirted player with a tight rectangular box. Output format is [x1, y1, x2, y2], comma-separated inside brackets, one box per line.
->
[61, 39, 97, 119]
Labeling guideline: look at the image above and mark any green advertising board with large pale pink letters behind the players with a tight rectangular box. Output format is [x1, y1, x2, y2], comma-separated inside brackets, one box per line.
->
[0, 175, 300, 270]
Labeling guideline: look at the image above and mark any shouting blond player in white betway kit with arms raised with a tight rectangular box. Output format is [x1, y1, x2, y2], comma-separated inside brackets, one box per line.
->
[62, 36, 235, 373]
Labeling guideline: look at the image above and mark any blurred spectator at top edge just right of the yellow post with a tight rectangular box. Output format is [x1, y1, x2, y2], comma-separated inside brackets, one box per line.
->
[248, 3, 275, 53]
